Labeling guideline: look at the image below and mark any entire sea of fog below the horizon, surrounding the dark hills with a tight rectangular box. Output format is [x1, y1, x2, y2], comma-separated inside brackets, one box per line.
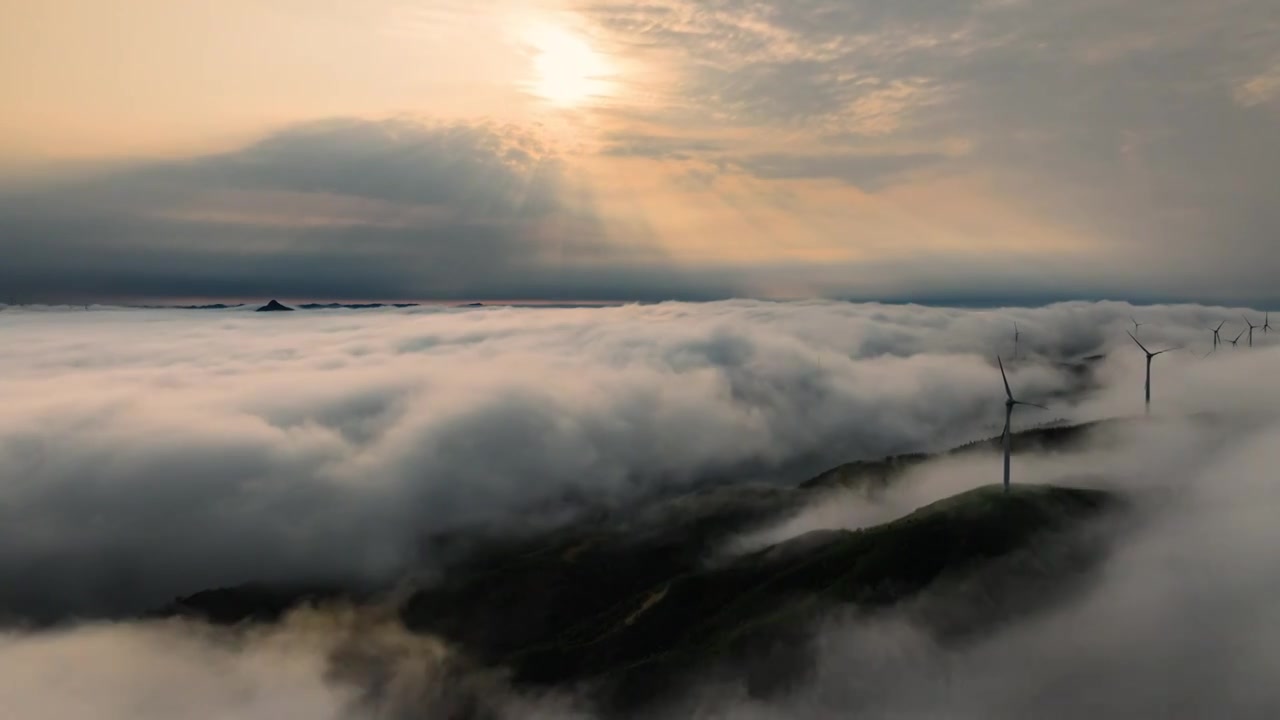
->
[0, 301, 1280, 720]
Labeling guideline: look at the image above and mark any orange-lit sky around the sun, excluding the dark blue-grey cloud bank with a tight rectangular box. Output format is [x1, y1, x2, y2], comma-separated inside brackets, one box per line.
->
[0, 0, 1280, 299]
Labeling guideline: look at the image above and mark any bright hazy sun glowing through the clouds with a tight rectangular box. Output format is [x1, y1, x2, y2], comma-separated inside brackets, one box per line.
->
[527, 26, 611, 106]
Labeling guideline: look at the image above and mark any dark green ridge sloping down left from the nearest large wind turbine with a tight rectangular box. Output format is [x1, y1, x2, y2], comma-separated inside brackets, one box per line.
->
[506, 486, 1114, 696]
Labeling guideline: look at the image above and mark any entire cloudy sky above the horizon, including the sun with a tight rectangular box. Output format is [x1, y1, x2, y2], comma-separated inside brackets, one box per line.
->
[0, 0, 1280, 306]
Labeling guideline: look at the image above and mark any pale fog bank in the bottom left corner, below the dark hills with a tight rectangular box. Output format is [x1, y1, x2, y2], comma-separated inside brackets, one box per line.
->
[0, 607, 585, 720]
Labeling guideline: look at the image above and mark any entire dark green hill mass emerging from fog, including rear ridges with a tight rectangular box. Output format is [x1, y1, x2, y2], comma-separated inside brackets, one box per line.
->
[149, 423, 1124, 708]
